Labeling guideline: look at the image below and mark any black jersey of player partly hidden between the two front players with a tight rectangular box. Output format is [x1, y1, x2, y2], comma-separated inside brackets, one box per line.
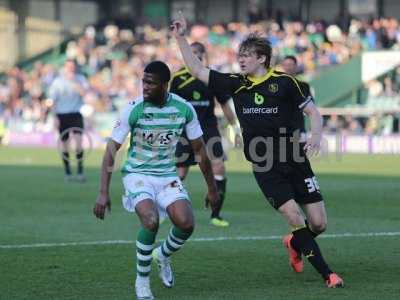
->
[170, 68, 230, 129]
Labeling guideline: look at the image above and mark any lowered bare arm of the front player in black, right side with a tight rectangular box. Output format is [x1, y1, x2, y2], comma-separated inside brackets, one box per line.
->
[303, 101, 322, 156]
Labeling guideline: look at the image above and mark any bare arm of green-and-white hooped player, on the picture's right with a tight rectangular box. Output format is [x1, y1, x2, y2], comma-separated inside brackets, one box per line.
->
[190, 137, 220, 208]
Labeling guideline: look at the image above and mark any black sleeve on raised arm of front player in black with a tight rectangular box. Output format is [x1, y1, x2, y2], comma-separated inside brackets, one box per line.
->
[208, 70, 242, 95]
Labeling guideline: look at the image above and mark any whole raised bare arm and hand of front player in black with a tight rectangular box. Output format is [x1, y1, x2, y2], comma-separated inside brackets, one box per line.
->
[171, 12, 210, 85]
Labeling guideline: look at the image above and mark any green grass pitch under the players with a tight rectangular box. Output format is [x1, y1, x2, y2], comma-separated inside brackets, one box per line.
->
[0, 147, 400, 299]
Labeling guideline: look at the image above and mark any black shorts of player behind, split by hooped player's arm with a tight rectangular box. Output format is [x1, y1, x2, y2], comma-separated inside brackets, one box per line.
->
[175, 127, 226, 167]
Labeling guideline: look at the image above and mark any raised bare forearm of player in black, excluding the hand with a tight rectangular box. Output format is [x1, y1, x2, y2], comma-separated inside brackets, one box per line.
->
[176, 36, 209, 85]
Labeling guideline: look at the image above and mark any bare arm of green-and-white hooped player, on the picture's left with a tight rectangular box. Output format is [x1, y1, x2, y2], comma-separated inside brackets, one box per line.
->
[93, 140, 121, 220]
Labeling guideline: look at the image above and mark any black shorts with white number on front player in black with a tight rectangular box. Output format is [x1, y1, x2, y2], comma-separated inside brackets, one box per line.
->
[253, 159, 323, 209]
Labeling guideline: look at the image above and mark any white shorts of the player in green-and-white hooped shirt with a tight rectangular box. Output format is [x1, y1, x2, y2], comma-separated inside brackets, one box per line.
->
[122, 173, 190, 220]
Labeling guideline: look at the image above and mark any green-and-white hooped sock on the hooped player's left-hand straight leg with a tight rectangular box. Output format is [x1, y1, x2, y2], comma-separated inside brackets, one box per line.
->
[136, 227, 157, 277]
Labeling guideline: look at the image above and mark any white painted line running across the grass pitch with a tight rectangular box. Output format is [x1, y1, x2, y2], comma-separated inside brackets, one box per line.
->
[0, 231, 400, 249]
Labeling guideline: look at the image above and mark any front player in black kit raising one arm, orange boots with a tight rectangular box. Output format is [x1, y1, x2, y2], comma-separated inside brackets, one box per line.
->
[171, 15, 344, 288]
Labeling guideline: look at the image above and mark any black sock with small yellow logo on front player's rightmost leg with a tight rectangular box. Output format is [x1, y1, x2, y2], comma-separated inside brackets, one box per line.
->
[291, 227, 332, 280]
